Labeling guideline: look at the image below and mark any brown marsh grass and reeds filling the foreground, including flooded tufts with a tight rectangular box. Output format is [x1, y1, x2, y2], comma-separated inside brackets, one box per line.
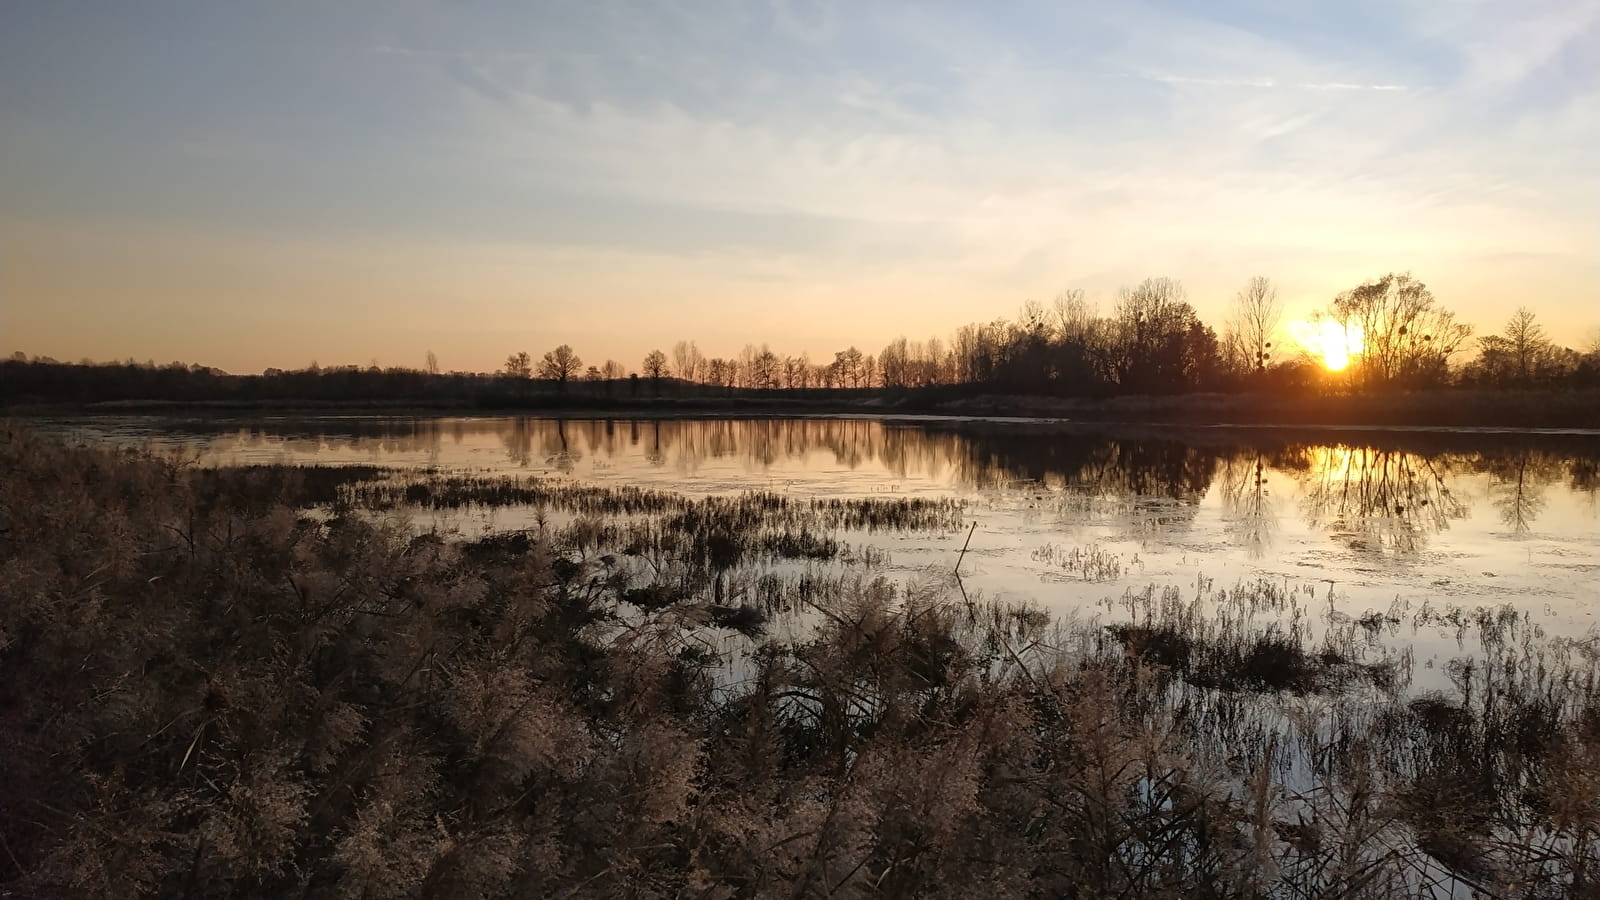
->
[0, 424, 1600, 898]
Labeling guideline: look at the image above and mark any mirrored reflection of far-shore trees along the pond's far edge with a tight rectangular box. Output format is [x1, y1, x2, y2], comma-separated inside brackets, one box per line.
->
[50, 416, 1600, 559]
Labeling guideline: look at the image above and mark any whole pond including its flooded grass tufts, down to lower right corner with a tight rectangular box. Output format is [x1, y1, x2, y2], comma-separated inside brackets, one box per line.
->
[15, 416, 1600, 898]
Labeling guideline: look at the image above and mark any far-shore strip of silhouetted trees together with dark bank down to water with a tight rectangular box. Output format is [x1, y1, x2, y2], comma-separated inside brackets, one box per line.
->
[0, 274, 1600, 426]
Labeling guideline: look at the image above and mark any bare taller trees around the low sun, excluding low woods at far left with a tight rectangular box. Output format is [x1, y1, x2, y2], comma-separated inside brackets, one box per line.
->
[501, 274, 1600, 396]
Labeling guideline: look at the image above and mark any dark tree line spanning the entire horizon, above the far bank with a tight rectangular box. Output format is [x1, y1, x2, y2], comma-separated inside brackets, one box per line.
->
[0, 274, 1600, 405]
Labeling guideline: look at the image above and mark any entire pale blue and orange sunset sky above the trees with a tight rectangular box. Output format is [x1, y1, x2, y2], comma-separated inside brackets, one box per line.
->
[0, 0, 1600, 372]
